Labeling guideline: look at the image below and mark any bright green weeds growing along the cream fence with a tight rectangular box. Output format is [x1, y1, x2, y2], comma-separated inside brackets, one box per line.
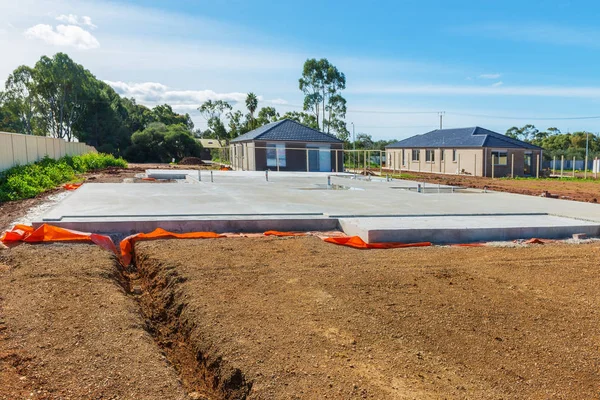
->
[0, 153, 127, 202]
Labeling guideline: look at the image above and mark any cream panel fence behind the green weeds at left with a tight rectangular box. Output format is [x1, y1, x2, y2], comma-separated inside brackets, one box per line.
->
[0, 132, 96, 171]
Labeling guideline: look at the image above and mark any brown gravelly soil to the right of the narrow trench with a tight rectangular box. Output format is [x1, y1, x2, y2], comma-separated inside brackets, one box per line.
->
[136, 237, 600, 399]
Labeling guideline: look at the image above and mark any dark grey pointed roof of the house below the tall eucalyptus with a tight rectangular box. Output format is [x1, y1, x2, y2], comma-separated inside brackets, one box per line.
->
[231, 119, 342, 143]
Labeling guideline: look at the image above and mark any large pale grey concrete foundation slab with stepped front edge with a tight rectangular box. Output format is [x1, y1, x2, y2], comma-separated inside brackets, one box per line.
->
[34, 171, 600, 242]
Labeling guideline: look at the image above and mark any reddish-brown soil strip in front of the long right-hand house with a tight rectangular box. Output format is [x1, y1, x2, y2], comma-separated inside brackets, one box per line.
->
[384, 172, 600, 203]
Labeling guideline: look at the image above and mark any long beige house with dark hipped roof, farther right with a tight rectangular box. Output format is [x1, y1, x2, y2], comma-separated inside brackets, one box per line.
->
[385, 126, 542, 177]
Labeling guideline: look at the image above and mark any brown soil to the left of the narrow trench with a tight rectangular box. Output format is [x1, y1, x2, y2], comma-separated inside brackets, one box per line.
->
[0, 244, 187, 399]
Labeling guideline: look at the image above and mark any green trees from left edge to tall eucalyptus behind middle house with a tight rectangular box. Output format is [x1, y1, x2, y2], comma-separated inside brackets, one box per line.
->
[0, 53, 349, 162]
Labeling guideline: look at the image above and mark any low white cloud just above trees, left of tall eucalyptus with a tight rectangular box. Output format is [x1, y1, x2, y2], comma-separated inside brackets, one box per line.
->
[105, 81, 262, 110]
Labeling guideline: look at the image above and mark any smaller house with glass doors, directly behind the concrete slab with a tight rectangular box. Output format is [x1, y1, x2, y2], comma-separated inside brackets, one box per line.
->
[229, 119, 344, 172]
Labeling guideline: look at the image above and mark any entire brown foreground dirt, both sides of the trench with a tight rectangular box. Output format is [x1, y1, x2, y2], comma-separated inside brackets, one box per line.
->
[0, 237, 600, 399]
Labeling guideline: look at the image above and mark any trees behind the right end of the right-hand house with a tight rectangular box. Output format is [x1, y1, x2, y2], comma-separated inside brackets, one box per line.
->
[506, 124, 600, 160]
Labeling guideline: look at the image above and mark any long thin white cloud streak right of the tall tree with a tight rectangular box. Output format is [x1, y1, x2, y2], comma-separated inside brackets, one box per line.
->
[346, 82, 600, 99]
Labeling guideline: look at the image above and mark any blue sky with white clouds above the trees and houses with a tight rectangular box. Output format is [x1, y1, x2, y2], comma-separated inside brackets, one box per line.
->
[0, 0, 600, 140]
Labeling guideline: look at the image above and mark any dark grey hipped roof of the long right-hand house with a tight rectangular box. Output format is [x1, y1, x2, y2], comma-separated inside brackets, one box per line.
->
[386, 126, 540, 149]
